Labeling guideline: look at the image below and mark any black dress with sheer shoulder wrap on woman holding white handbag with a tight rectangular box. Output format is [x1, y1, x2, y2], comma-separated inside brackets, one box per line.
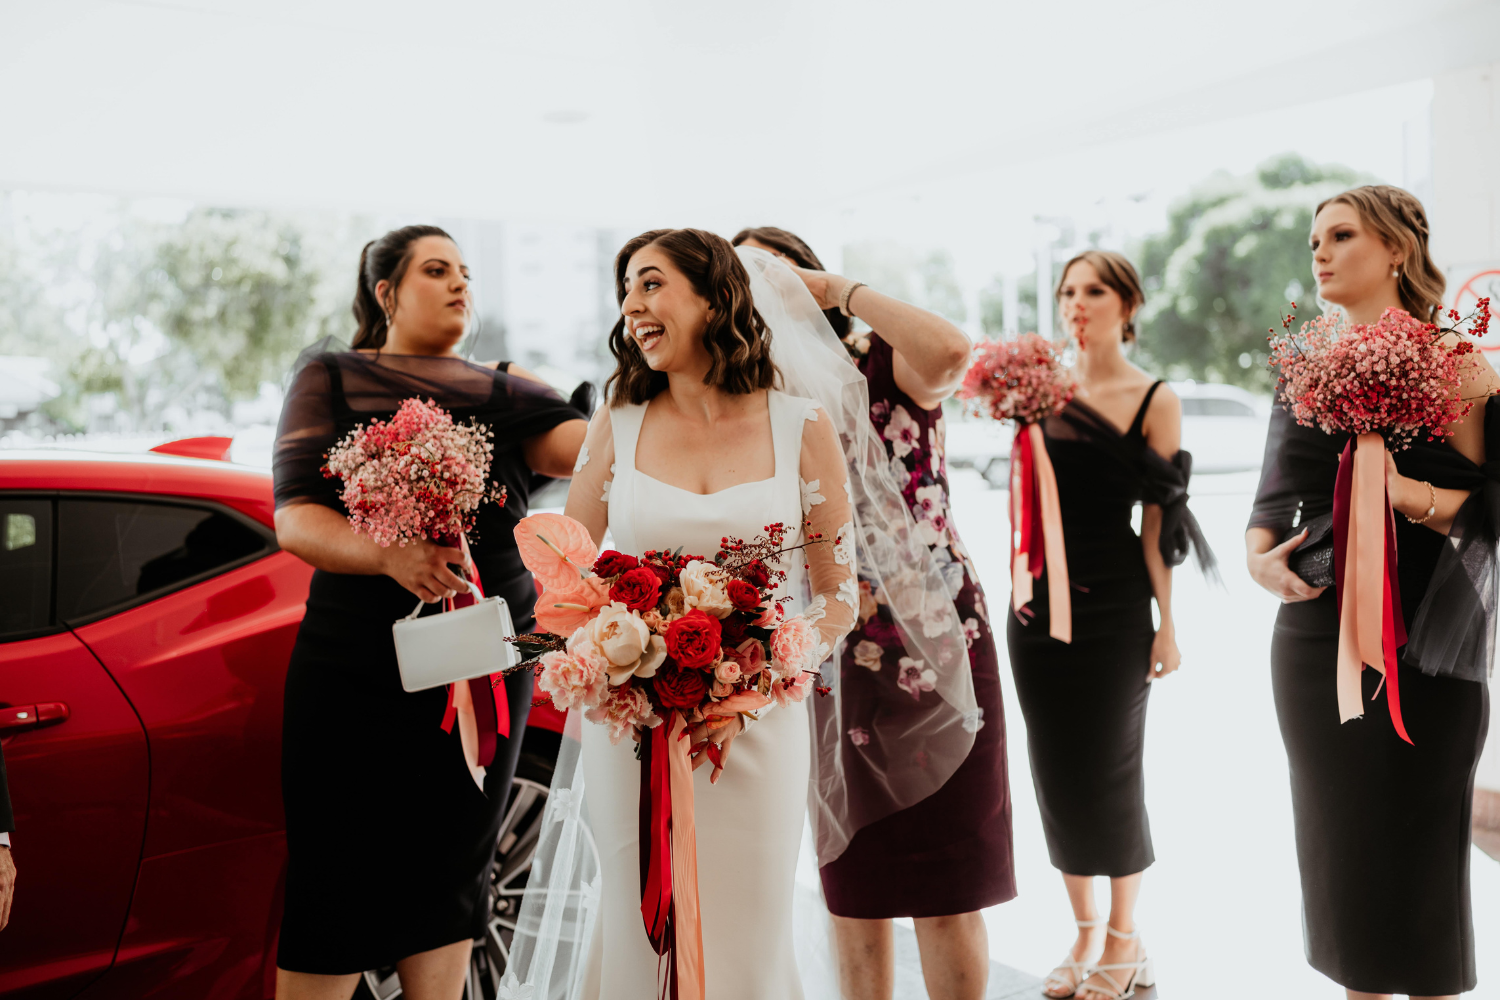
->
[275, 352, 584, 975]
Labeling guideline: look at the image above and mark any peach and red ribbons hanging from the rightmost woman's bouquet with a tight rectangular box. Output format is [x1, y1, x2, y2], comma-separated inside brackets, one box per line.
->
[1334, 433, 1412, 744]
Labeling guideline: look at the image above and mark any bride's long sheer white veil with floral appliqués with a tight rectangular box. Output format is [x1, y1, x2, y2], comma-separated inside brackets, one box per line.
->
[500, 247, 978, 1000]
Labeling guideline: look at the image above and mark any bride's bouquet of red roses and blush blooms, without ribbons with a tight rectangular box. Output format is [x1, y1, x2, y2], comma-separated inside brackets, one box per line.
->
[516, 514, 828, 749]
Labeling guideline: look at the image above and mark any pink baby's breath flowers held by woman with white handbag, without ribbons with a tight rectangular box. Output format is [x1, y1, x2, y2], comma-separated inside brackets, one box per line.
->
[323, 399, 506, 547]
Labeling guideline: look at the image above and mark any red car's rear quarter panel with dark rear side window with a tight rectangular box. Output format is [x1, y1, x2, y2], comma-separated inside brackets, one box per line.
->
[59, 498, 312, 1000]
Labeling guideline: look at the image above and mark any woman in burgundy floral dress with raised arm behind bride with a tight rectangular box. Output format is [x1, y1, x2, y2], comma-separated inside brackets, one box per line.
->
[734, 226, 1016, 1000]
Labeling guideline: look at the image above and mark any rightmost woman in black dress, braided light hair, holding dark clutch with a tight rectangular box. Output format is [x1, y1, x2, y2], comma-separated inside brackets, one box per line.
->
[1245, 186, 1500, 997]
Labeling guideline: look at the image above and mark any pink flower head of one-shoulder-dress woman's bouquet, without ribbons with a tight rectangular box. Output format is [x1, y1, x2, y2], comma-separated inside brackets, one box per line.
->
[959, 333, 1077, 424]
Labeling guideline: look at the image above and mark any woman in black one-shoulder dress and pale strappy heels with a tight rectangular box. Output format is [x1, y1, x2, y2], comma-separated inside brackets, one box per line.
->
[1007, 250, 1212, 1000]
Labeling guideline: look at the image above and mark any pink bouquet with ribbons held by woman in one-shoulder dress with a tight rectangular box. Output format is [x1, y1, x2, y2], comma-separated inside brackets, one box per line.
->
[959, 333, 1079, 642]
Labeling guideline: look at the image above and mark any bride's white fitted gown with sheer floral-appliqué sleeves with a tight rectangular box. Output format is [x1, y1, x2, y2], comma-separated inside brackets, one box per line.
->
[569, 391, 858, 1000]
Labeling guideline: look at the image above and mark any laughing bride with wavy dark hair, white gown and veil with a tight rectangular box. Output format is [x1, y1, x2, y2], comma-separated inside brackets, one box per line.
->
[500, 229, 972, 1000]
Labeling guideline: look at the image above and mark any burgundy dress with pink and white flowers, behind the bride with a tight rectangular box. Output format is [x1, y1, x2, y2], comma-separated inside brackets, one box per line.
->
[821, 334, 1016, 919]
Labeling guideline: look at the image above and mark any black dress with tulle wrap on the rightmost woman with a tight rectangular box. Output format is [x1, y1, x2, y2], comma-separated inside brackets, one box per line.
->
[1250, 399, 1500, 996]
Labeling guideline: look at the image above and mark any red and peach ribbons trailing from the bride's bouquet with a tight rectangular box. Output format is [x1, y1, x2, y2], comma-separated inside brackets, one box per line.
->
[641, 711, 705, 1000]
